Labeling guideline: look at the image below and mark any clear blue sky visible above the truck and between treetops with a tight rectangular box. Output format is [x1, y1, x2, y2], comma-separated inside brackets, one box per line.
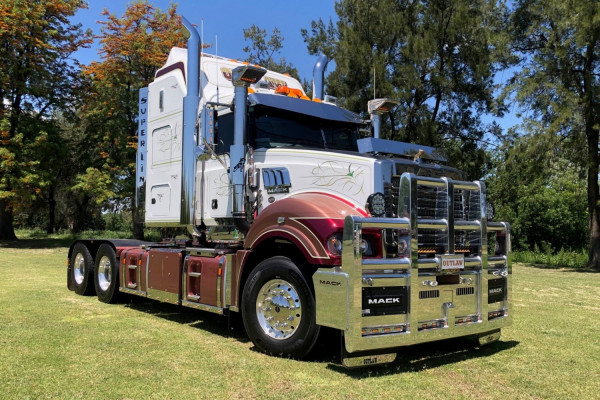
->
[73, 0, 337, 80]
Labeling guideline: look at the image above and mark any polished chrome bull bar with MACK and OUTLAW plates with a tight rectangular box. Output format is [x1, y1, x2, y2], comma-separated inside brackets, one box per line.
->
[313, 173, 512, 353]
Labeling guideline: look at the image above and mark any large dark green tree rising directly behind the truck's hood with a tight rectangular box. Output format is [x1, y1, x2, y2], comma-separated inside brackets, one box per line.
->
[302, 0, 509, 178]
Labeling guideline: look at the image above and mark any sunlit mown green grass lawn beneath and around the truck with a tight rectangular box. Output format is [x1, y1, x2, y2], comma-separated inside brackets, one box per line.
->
[0, 239, 600, 400]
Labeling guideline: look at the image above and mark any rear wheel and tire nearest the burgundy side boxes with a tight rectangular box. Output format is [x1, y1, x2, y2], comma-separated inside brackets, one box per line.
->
[94, 243, 119, 303]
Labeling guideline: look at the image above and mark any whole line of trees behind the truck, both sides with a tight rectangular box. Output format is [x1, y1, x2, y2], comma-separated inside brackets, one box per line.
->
[0, 0, 600, 269]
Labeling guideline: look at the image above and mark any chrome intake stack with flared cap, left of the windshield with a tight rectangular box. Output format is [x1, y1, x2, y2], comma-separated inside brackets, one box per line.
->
[229, 65, 267, 235]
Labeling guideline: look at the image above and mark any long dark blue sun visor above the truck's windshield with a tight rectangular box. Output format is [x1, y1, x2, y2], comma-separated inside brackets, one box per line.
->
[248, 93, 362, 124]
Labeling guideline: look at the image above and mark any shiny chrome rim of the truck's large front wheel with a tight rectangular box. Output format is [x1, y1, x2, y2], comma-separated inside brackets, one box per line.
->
[256, 279, 302, 340]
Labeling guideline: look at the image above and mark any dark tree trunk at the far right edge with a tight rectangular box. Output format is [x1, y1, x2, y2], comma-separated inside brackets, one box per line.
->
[586, 126, 600, 271]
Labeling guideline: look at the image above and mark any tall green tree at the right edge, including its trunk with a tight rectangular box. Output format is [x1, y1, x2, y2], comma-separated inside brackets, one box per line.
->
[509, 0, 600, 270]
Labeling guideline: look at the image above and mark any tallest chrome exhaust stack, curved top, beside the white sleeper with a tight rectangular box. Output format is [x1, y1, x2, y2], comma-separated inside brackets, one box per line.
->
[179, 17, 202, 234]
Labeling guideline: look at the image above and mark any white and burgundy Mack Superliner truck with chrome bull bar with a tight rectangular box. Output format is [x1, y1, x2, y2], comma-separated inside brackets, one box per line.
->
[67, 18, 512, 367]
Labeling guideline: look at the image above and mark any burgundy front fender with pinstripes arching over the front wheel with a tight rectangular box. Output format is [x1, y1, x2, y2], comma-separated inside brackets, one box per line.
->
[245, 192, 366, 265]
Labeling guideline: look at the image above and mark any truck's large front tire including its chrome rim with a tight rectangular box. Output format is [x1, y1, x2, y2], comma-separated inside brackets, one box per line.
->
[242, 256, 320, 358]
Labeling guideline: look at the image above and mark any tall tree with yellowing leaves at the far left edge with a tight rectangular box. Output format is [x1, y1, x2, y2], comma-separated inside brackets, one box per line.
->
[0, 0, 91, 240]
